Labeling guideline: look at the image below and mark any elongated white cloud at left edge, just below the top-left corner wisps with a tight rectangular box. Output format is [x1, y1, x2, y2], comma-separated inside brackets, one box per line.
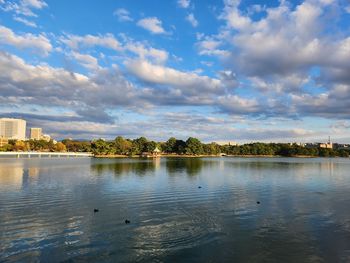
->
[0, 26, 52, 56]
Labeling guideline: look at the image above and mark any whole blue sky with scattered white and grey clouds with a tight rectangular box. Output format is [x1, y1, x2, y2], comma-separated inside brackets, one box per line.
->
[0, 0, 350, 143]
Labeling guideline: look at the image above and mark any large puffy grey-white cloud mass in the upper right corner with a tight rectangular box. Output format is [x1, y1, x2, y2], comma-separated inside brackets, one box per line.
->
[220, 0, 349, 80]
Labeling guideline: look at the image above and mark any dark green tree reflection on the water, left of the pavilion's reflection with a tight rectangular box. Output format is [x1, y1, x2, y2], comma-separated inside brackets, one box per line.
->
[91, 161, 157, 176]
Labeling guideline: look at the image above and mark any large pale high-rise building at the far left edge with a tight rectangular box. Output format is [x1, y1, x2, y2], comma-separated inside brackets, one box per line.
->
[0, 118, 26, 140]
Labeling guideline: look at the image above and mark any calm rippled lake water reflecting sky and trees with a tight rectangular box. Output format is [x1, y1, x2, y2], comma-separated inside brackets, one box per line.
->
[0, 157, 350, 262]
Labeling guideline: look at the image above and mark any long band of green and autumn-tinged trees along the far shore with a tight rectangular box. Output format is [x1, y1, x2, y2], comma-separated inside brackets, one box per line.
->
[0, 136, 350, 157]
